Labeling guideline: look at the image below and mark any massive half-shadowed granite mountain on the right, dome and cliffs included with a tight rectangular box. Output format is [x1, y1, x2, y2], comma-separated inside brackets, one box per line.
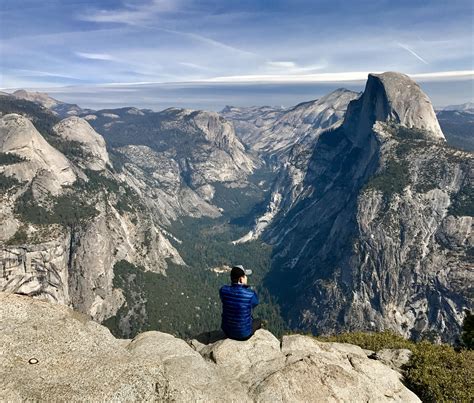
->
[262, 73, 474, 341]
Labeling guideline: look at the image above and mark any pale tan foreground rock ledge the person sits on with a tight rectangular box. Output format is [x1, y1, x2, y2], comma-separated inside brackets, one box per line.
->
[0, 293, 419, 402]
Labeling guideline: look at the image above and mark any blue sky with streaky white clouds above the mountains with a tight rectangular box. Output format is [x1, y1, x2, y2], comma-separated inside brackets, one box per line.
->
[0, 0, 474, 109]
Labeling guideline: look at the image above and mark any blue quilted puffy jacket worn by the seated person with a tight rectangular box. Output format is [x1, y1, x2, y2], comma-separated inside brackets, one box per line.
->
[219, 283, 259, 340]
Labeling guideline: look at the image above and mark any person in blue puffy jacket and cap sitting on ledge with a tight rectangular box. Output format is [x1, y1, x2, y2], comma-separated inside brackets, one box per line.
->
[219, 265, 262, 340]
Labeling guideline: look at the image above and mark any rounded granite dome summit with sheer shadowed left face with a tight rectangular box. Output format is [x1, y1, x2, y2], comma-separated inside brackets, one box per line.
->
[344, 72, 445, 141]
